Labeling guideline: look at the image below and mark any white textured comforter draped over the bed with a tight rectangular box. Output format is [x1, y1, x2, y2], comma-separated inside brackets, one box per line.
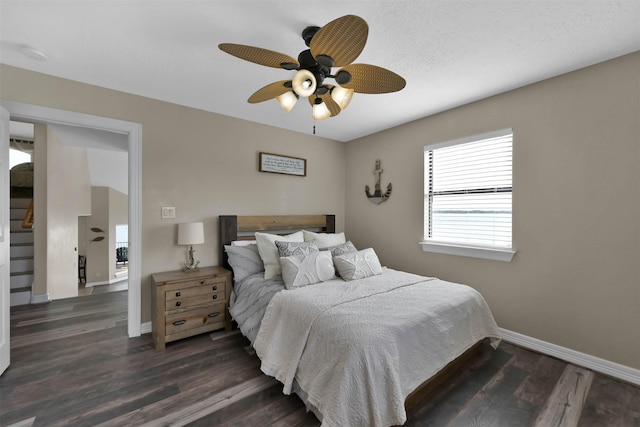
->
[254, 269, 500, 427]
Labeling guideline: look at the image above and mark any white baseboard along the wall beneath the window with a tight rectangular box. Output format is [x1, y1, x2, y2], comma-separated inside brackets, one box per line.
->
[500, 328, 640, 386]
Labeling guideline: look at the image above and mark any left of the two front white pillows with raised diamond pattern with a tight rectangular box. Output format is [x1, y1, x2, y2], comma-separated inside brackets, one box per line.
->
[280, 251, 336, 289]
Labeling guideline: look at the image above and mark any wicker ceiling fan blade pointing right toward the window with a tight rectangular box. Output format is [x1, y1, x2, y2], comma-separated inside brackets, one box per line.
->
[340, 64, 407, 93]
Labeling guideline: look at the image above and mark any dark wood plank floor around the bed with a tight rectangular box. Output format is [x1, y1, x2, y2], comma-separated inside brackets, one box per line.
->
[0, 291, 640, 427]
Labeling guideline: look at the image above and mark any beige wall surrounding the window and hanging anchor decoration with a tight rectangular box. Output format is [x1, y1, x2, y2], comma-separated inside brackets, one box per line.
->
[345, 53, 640, 368]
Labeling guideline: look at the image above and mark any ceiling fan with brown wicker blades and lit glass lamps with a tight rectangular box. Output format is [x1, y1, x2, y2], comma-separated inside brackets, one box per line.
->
[218, 15, 406, 120]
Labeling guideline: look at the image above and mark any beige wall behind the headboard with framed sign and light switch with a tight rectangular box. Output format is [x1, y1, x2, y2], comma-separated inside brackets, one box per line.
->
[0, 65, 346, 322]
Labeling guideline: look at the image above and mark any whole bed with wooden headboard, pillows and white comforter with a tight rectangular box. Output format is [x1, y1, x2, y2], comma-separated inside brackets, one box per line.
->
[220, 215, 500, 426]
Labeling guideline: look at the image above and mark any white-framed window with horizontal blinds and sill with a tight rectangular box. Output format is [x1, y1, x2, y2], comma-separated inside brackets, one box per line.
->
[422, 129, 514, 261]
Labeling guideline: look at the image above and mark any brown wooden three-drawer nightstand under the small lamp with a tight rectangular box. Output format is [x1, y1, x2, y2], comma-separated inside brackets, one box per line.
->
[151, 267, 231, 351]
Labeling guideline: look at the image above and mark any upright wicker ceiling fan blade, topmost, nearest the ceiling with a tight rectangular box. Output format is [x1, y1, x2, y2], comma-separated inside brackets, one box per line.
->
[309, 15, 369, 67]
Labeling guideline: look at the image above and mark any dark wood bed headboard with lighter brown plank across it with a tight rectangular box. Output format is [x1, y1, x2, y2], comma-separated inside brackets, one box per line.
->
[219, 215, 336, 269]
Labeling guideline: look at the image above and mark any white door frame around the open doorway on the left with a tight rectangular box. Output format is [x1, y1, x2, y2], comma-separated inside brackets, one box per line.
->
[0, 99, 142, 338]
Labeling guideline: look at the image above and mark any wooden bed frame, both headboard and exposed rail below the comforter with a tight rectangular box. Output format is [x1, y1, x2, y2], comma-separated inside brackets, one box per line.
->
[219, 215, 484, 416]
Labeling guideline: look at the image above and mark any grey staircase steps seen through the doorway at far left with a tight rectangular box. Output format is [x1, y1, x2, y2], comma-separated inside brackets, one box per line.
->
[9, 198, 34, 307]
